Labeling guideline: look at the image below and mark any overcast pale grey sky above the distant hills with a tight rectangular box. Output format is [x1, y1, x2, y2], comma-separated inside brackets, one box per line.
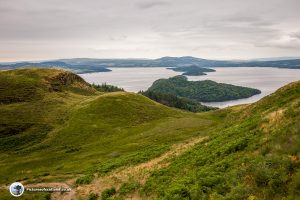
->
[0, 0, 300, 62]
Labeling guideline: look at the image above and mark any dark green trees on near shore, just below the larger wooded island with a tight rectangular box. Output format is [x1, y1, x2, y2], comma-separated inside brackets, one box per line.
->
[139, 91, 216, 112]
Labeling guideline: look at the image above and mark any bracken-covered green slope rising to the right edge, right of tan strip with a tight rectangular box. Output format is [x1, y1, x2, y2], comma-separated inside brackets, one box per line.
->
[143, 82, 300, 199]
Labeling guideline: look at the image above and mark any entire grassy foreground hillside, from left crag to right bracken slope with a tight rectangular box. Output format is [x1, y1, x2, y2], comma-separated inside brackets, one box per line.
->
[0, 69, 300, 199]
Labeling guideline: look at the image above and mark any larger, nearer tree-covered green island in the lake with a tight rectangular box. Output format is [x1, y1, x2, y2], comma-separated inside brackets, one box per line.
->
[147, 76, 260, 102]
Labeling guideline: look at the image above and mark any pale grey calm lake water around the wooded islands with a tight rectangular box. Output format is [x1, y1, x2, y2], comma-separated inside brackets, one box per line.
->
[80, 67, 300, 108]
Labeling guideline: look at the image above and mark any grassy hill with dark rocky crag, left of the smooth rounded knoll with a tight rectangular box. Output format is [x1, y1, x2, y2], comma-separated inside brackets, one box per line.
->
[0, 69, 96, 151]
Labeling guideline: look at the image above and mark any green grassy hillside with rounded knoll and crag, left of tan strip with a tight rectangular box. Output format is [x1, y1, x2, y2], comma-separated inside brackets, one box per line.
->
[0, 69, 220, 196]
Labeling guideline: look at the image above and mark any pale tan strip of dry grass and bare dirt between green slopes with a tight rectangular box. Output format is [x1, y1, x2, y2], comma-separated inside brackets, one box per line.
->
[1, 137, 208, 200]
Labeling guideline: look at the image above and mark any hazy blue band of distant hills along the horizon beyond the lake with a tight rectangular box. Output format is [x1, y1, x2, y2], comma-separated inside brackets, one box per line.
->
[0, 56, 300, 73]
